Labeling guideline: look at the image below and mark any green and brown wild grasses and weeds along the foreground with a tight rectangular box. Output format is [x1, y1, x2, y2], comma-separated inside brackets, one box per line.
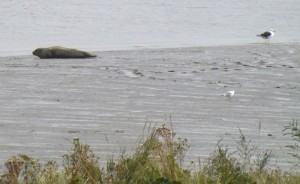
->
[0, 121, 300, 184]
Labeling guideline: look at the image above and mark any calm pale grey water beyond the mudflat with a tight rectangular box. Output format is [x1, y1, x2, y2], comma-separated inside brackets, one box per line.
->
[0, 0, 300, 56]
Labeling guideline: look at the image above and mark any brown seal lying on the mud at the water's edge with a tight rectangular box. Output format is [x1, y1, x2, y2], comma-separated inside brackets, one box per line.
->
[32, 46, 97, 59]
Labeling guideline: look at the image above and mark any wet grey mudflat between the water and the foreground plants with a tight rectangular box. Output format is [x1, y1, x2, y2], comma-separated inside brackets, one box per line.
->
[0, 44, 300, 168]
